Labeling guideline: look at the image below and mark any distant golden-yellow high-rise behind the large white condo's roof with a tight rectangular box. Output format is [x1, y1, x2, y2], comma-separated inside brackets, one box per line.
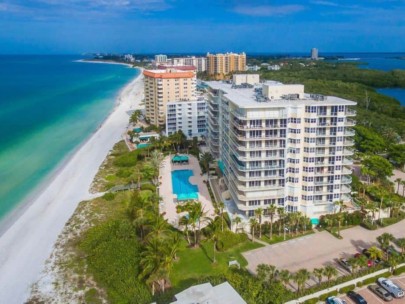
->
[207, 53, 246, 75]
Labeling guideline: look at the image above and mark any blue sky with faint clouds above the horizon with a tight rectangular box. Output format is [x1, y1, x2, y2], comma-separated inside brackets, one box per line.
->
[0, 0, 405, 54]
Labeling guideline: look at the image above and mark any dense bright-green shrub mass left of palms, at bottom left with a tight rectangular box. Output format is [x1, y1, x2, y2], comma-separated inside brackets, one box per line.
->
[79, 220, 152, 304]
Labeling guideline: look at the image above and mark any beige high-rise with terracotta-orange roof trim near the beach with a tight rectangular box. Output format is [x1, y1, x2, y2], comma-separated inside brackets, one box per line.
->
[143, 69, 196, 126]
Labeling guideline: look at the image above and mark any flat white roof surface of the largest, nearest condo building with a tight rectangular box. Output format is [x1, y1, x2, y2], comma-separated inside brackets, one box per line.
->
[205, 81, 357, 109]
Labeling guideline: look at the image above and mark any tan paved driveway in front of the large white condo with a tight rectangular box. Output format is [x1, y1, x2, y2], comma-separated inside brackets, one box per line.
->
[243, 221, 405, 273]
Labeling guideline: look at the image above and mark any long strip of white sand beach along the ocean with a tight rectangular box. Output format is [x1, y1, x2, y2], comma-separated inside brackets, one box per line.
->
[0, 73, 143, 304]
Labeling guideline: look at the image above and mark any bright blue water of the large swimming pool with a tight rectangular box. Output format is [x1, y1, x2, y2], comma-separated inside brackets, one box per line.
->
[172, 170, 198, 201]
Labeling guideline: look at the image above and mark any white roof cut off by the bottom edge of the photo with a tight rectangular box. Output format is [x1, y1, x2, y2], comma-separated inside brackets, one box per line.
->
[172, 282, 246, 304]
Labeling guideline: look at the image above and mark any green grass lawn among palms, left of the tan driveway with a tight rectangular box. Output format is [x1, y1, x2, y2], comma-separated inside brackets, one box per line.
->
[170, 241, 263, 290]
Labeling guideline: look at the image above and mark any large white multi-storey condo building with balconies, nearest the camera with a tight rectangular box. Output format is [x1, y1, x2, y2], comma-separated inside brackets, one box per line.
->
[207, 81, 356, 218]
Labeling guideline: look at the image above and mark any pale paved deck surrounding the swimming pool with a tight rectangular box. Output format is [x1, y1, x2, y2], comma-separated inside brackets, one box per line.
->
[159, 155, 215, 227]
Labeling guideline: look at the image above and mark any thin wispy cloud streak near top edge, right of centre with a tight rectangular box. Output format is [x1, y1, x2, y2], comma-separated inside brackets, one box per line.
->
[233, 4, 305, 17]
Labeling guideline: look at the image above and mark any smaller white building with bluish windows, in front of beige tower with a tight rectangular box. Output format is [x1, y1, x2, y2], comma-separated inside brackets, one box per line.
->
[166, 98, 207, 139]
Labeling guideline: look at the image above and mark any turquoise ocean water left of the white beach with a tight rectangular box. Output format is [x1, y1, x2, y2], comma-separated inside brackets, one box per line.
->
[0, 56, 139, 219]
